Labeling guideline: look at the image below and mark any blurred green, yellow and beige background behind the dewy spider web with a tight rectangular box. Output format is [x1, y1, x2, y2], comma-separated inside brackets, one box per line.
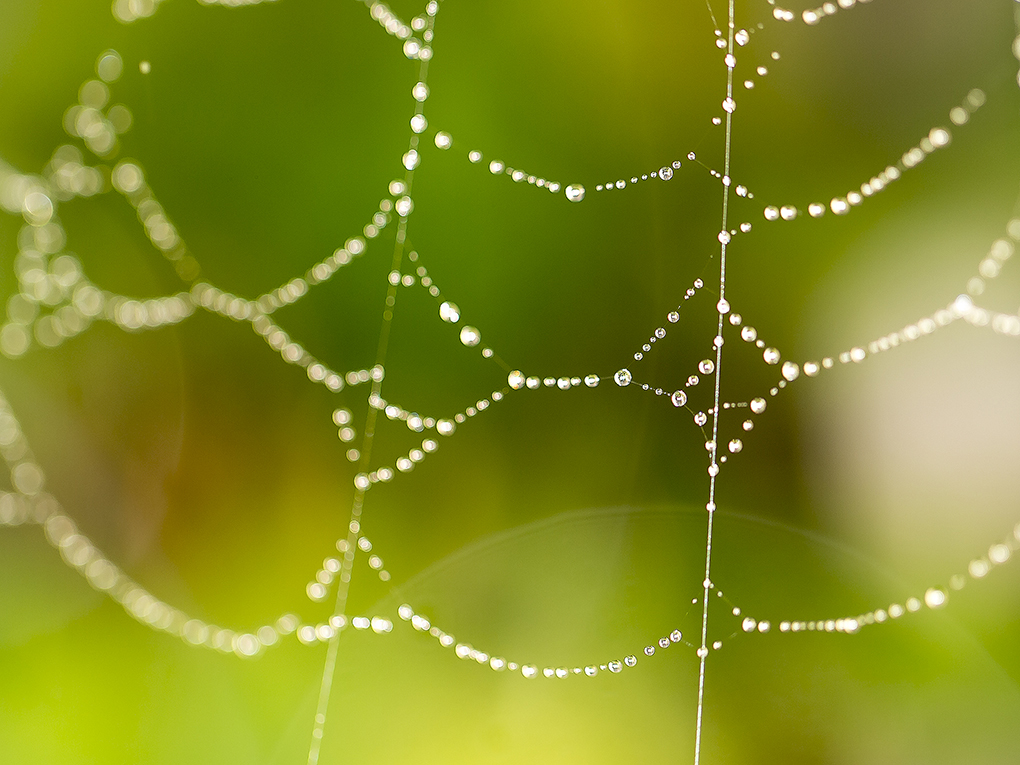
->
[0, 0, 1020, 765]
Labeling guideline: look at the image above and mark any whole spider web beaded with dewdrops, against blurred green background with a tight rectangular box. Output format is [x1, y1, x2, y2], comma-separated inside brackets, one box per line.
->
[0, 0, 1020, 763]
